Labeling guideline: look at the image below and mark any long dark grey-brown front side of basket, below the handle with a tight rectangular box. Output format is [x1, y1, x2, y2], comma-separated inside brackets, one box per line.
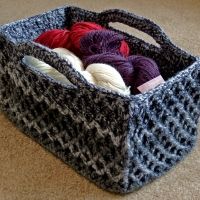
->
[0, 47, 129, 192]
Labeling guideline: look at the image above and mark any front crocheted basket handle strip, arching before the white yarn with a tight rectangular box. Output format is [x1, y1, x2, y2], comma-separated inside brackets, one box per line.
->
[15, 42, 91, 88]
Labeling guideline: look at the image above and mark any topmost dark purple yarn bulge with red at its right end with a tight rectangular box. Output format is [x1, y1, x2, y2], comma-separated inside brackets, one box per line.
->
[80, 30, 129, 56]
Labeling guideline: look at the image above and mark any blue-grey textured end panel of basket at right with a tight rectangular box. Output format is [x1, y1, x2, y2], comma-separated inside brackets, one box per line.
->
[127, 61, 200, 191]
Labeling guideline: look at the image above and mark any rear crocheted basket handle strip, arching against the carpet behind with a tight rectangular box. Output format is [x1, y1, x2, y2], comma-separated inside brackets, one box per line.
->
[99, 9, 175, 49]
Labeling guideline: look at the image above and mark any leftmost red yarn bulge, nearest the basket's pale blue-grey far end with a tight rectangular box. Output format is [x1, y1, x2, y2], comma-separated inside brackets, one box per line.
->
[34, 29, 71, 49]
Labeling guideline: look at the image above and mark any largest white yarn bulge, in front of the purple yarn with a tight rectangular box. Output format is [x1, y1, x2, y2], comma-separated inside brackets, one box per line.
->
[86, 63, 130, 95]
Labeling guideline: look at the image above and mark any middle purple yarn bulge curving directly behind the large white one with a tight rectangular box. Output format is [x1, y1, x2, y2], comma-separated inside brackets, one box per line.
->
[83, 53, 134, 86]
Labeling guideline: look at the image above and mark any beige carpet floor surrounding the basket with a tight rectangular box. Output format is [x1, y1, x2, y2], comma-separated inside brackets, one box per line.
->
[0, 0, 200, 200]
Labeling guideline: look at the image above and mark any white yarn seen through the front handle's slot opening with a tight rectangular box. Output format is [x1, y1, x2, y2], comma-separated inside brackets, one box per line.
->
[23, 56, 72, 84]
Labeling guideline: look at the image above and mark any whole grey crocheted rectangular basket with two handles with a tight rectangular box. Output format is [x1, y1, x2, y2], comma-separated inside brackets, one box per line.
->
[0, 7, 200, 193]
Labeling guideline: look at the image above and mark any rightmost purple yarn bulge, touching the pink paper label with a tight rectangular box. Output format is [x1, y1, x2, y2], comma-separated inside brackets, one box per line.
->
[128, 55, 160, 94]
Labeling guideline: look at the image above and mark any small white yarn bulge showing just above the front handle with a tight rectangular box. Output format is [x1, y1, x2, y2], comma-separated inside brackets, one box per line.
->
[53, 48, 84, 72]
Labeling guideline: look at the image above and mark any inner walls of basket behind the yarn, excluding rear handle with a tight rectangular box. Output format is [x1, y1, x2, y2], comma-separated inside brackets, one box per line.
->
[0, 7, 196, 80]
